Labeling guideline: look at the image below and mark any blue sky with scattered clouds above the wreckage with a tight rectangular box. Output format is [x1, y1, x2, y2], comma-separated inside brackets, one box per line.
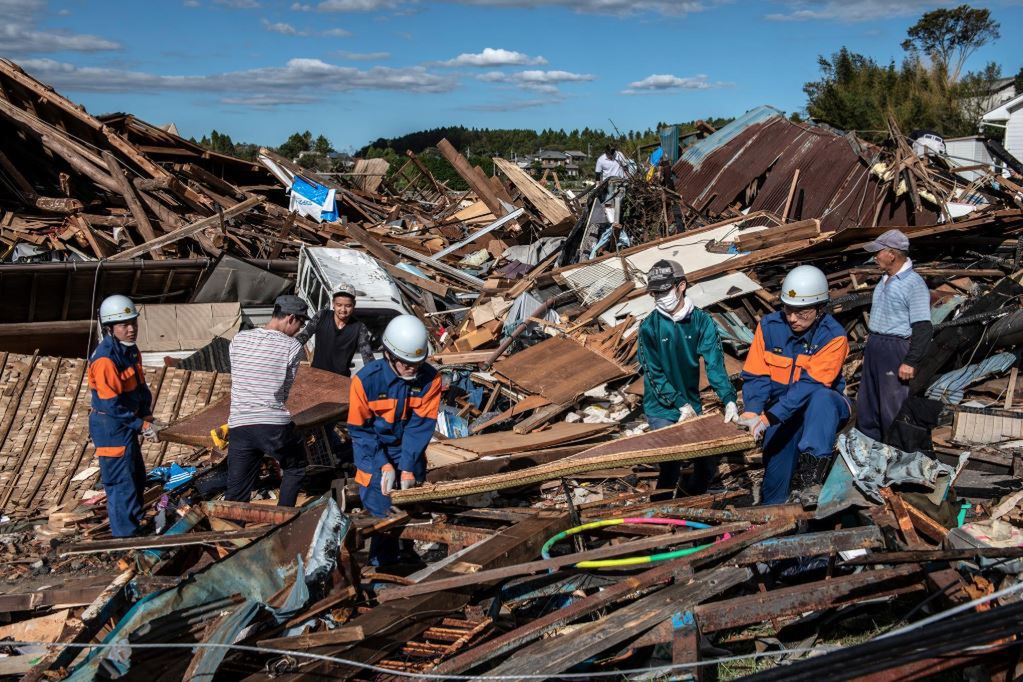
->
[7, 0, 1023, 149]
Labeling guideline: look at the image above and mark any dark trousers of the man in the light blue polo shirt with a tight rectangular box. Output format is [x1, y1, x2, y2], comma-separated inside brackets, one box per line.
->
[856, 334, 909, 442]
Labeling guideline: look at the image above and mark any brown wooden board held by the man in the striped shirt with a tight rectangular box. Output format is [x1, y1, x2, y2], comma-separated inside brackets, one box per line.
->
[160, 365, 352, 448]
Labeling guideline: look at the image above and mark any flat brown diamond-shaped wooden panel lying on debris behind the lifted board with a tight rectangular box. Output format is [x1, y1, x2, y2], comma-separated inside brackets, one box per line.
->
[493, 336, 632, 405]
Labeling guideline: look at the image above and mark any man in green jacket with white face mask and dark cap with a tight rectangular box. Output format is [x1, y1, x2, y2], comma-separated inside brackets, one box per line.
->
[639, 261, 739, 500]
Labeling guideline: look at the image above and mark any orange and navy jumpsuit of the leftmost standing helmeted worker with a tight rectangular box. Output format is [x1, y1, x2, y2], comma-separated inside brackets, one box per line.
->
[89, 336, 152, 538]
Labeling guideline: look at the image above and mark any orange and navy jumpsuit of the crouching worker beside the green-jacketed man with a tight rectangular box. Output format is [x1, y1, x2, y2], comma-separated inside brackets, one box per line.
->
[743, 312, 850, 504]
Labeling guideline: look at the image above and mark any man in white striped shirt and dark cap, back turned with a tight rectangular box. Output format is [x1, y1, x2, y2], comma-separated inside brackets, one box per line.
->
[224, 295, 309, 507]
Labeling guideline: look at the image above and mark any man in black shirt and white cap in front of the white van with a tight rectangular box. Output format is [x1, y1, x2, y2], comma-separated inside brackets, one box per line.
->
[295, 284, 373, 376]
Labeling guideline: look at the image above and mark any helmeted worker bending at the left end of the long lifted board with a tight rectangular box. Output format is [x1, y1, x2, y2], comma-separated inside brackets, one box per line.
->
[348, 315, 441, 566]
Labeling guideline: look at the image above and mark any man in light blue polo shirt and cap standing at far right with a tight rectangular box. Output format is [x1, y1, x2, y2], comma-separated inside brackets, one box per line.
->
[856, 230, 933, 441]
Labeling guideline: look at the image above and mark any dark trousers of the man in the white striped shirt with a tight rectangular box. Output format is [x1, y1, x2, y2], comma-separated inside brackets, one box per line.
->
[230, 423, 306, 507]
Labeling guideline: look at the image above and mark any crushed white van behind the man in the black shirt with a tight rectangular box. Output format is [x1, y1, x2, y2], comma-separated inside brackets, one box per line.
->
[295, 246, 411, 375]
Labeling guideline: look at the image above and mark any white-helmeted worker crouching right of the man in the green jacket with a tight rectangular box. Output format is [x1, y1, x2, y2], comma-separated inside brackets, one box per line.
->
[739, 265, 850, 504]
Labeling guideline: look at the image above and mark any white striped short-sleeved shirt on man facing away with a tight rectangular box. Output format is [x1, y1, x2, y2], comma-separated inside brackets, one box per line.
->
[227, 328, 302, 428]
